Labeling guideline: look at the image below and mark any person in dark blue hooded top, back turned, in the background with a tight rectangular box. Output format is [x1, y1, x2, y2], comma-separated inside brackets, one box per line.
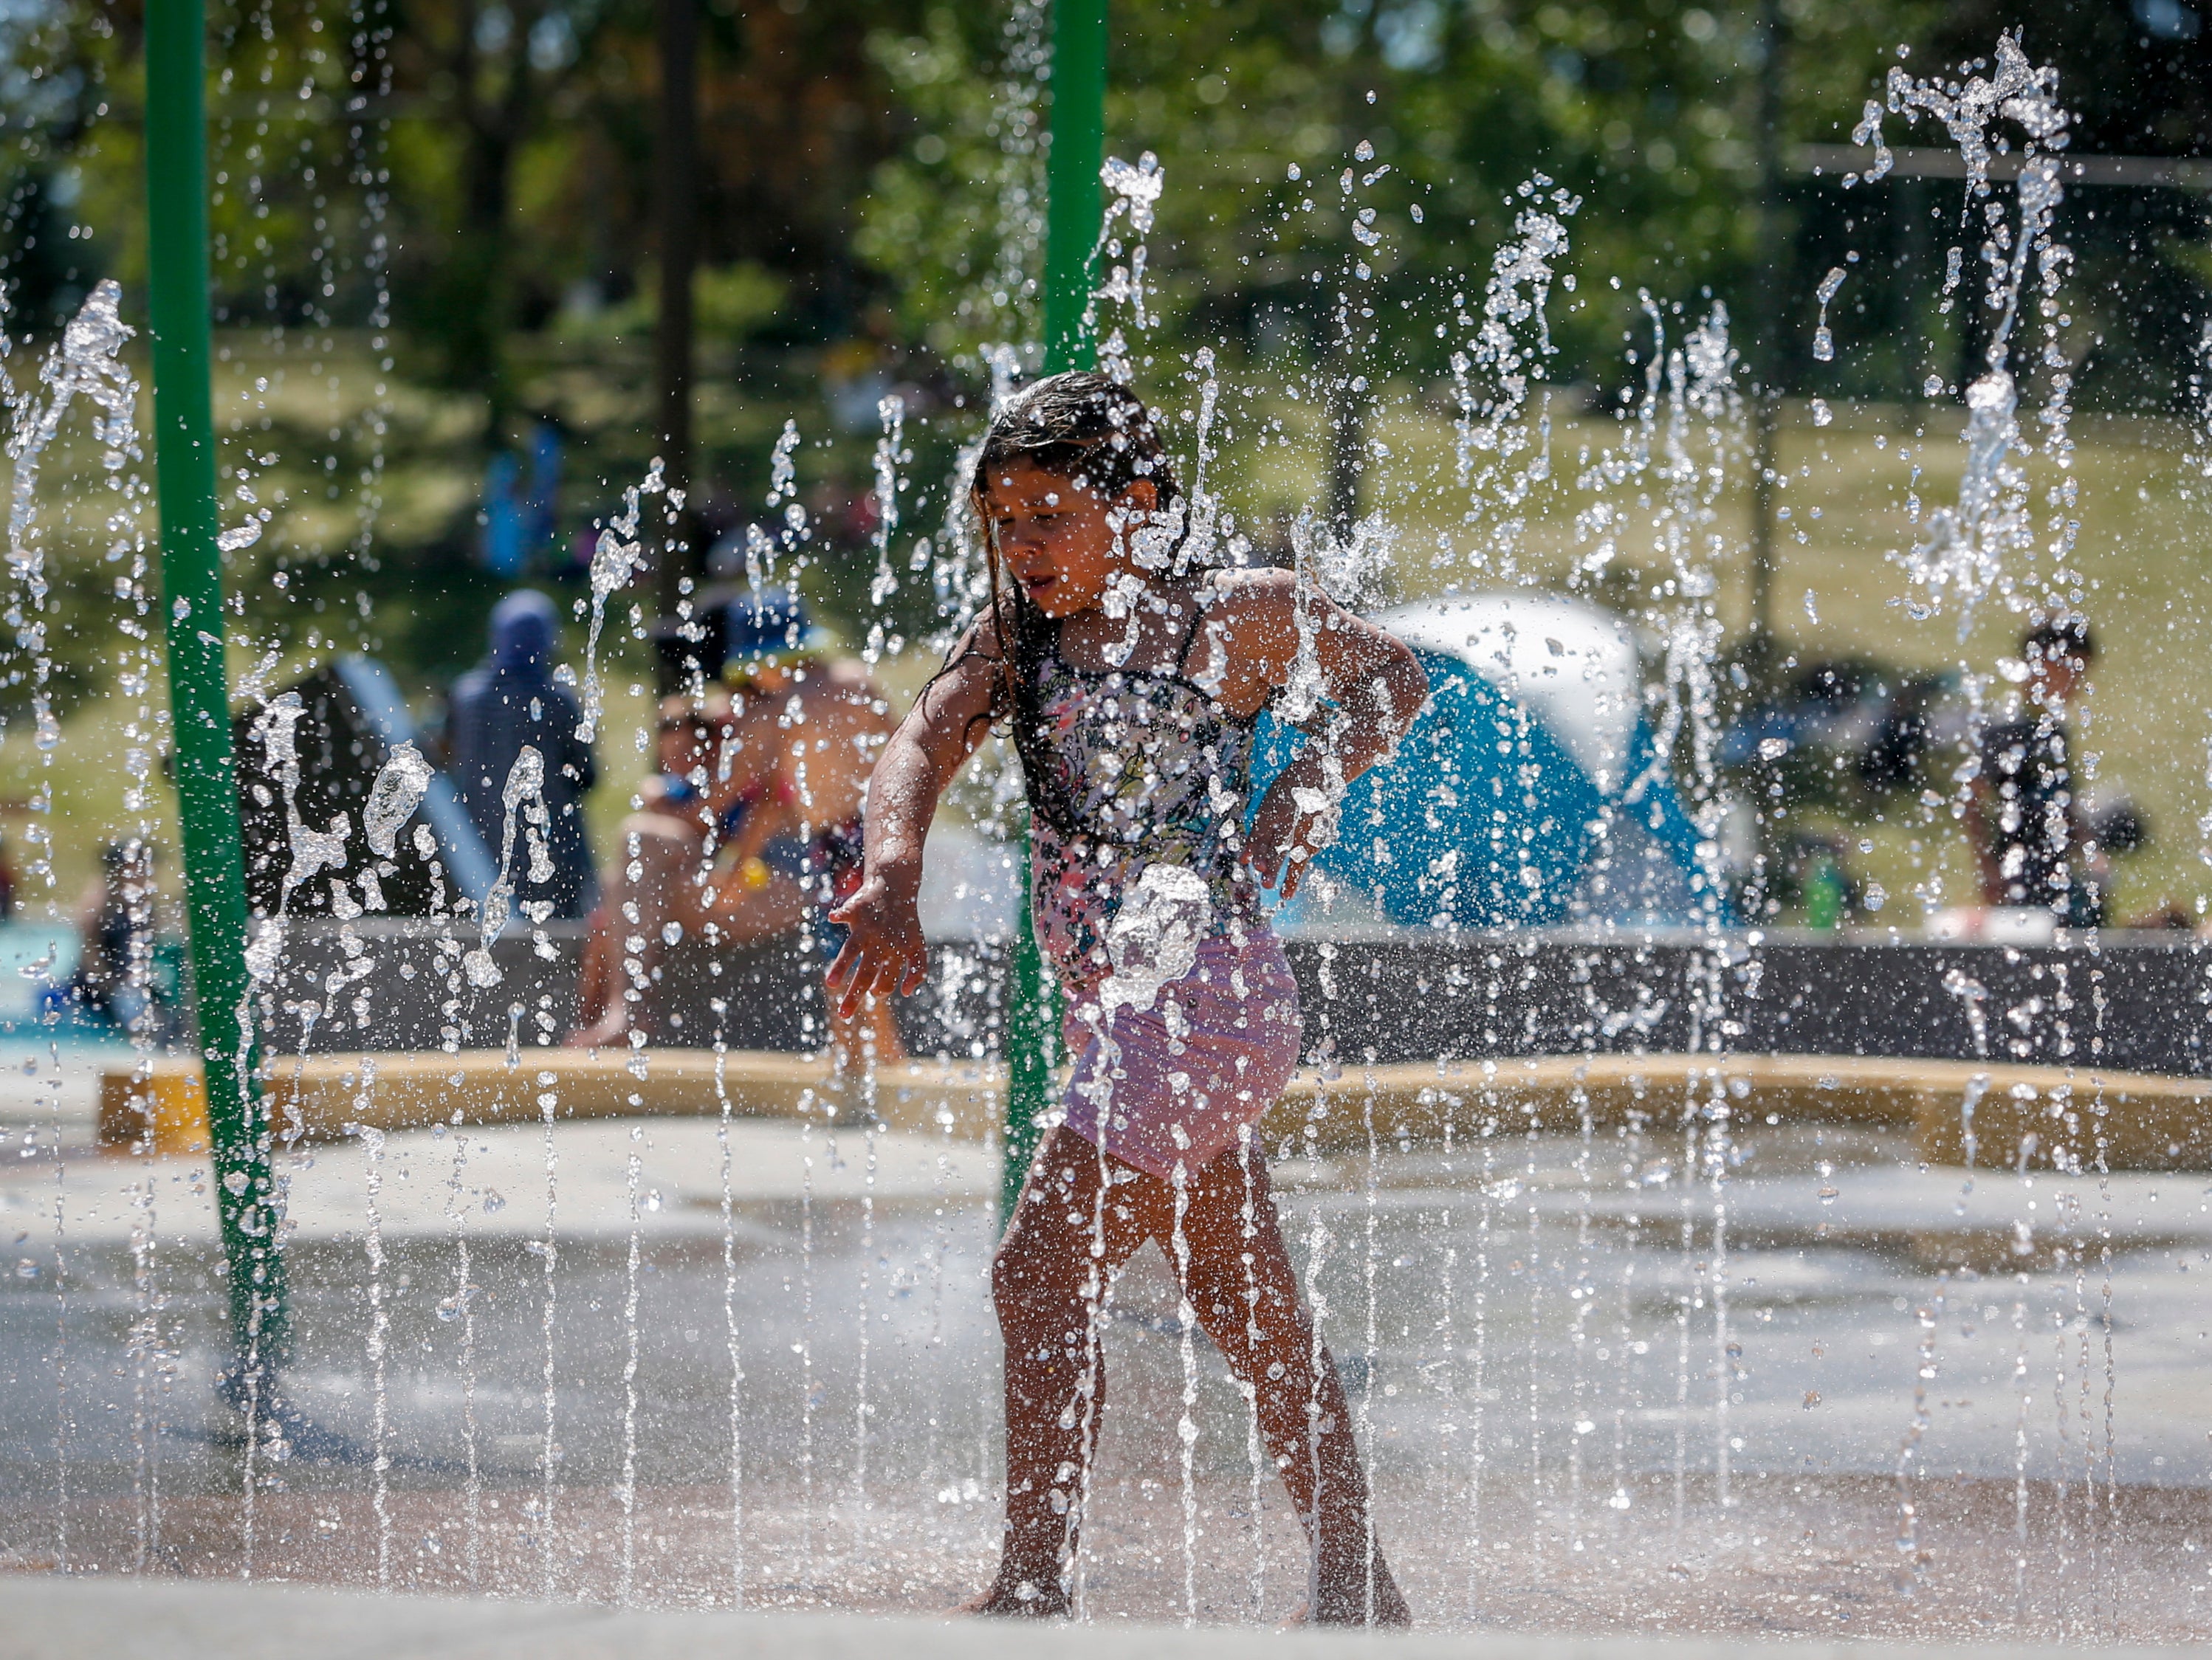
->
[444, 588, 600, 917]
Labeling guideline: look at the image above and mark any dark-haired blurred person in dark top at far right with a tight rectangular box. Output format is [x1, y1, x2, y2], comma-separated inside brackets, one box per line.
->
[1968, 617, 2143, 929]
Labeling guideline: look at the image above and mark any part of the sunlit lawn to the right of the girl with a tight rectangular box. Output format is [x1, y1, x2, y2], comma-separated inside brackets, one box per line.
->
[1221, 396, 2212, 926]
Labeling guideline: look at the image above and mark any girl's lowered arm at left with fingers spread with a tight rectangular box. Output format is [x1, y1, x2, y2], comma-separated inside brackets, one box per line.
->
[830, 613, 1000, 1015]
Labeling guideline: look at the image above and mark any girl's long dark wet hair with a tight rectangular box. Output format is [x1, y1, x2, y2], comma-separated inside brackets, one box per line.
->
[947, 369, 1181, 836]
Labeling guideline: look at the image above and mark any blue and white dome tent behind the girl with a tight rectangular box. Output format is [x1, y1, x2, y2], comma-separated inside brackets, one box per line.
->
[1254, 593, 1714, 931]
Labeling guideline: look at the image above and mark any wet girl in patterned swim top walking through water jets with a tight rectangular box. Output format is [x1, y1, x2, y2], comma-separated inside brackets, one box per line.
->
[830, 373, 1426, 1625]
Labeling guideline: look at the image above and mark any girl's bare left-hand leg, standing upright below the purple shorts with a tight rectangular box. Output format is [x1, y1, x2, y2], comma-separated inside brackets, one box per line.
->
[969, 1127, 1164, 1616]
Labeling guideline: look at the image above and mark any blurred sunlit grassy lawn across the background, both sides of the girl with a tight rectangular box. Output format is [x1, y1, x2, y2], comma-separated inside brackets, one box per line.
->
[0, 336, 2212, 941]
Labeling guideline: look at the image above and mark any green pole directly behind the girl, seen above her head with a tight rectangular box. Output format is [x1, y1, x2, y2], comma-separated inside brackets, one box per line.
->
[997, 0, 1106, 1227]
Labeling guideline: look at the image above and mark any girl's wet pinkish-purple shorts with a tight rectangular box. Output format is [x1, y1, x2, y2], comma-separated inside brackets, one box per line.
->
[1062, 929, 1301, 1180]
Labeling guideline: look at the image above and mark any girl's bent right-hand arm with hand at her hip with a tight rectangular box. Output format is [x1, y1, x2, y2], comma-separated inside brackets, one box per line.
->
[1192, 571, 1429, 900]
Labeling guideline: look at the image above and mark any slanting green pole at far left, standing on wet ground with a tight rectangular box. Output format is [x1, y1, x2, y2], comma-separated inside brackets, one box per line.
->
[146, 0, 287, 1379]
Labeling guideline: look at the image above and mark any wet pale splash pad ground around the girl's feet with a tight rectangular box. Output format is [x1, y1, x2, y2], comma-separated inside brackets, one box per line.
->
[0, 1039, 2212, 1642]
